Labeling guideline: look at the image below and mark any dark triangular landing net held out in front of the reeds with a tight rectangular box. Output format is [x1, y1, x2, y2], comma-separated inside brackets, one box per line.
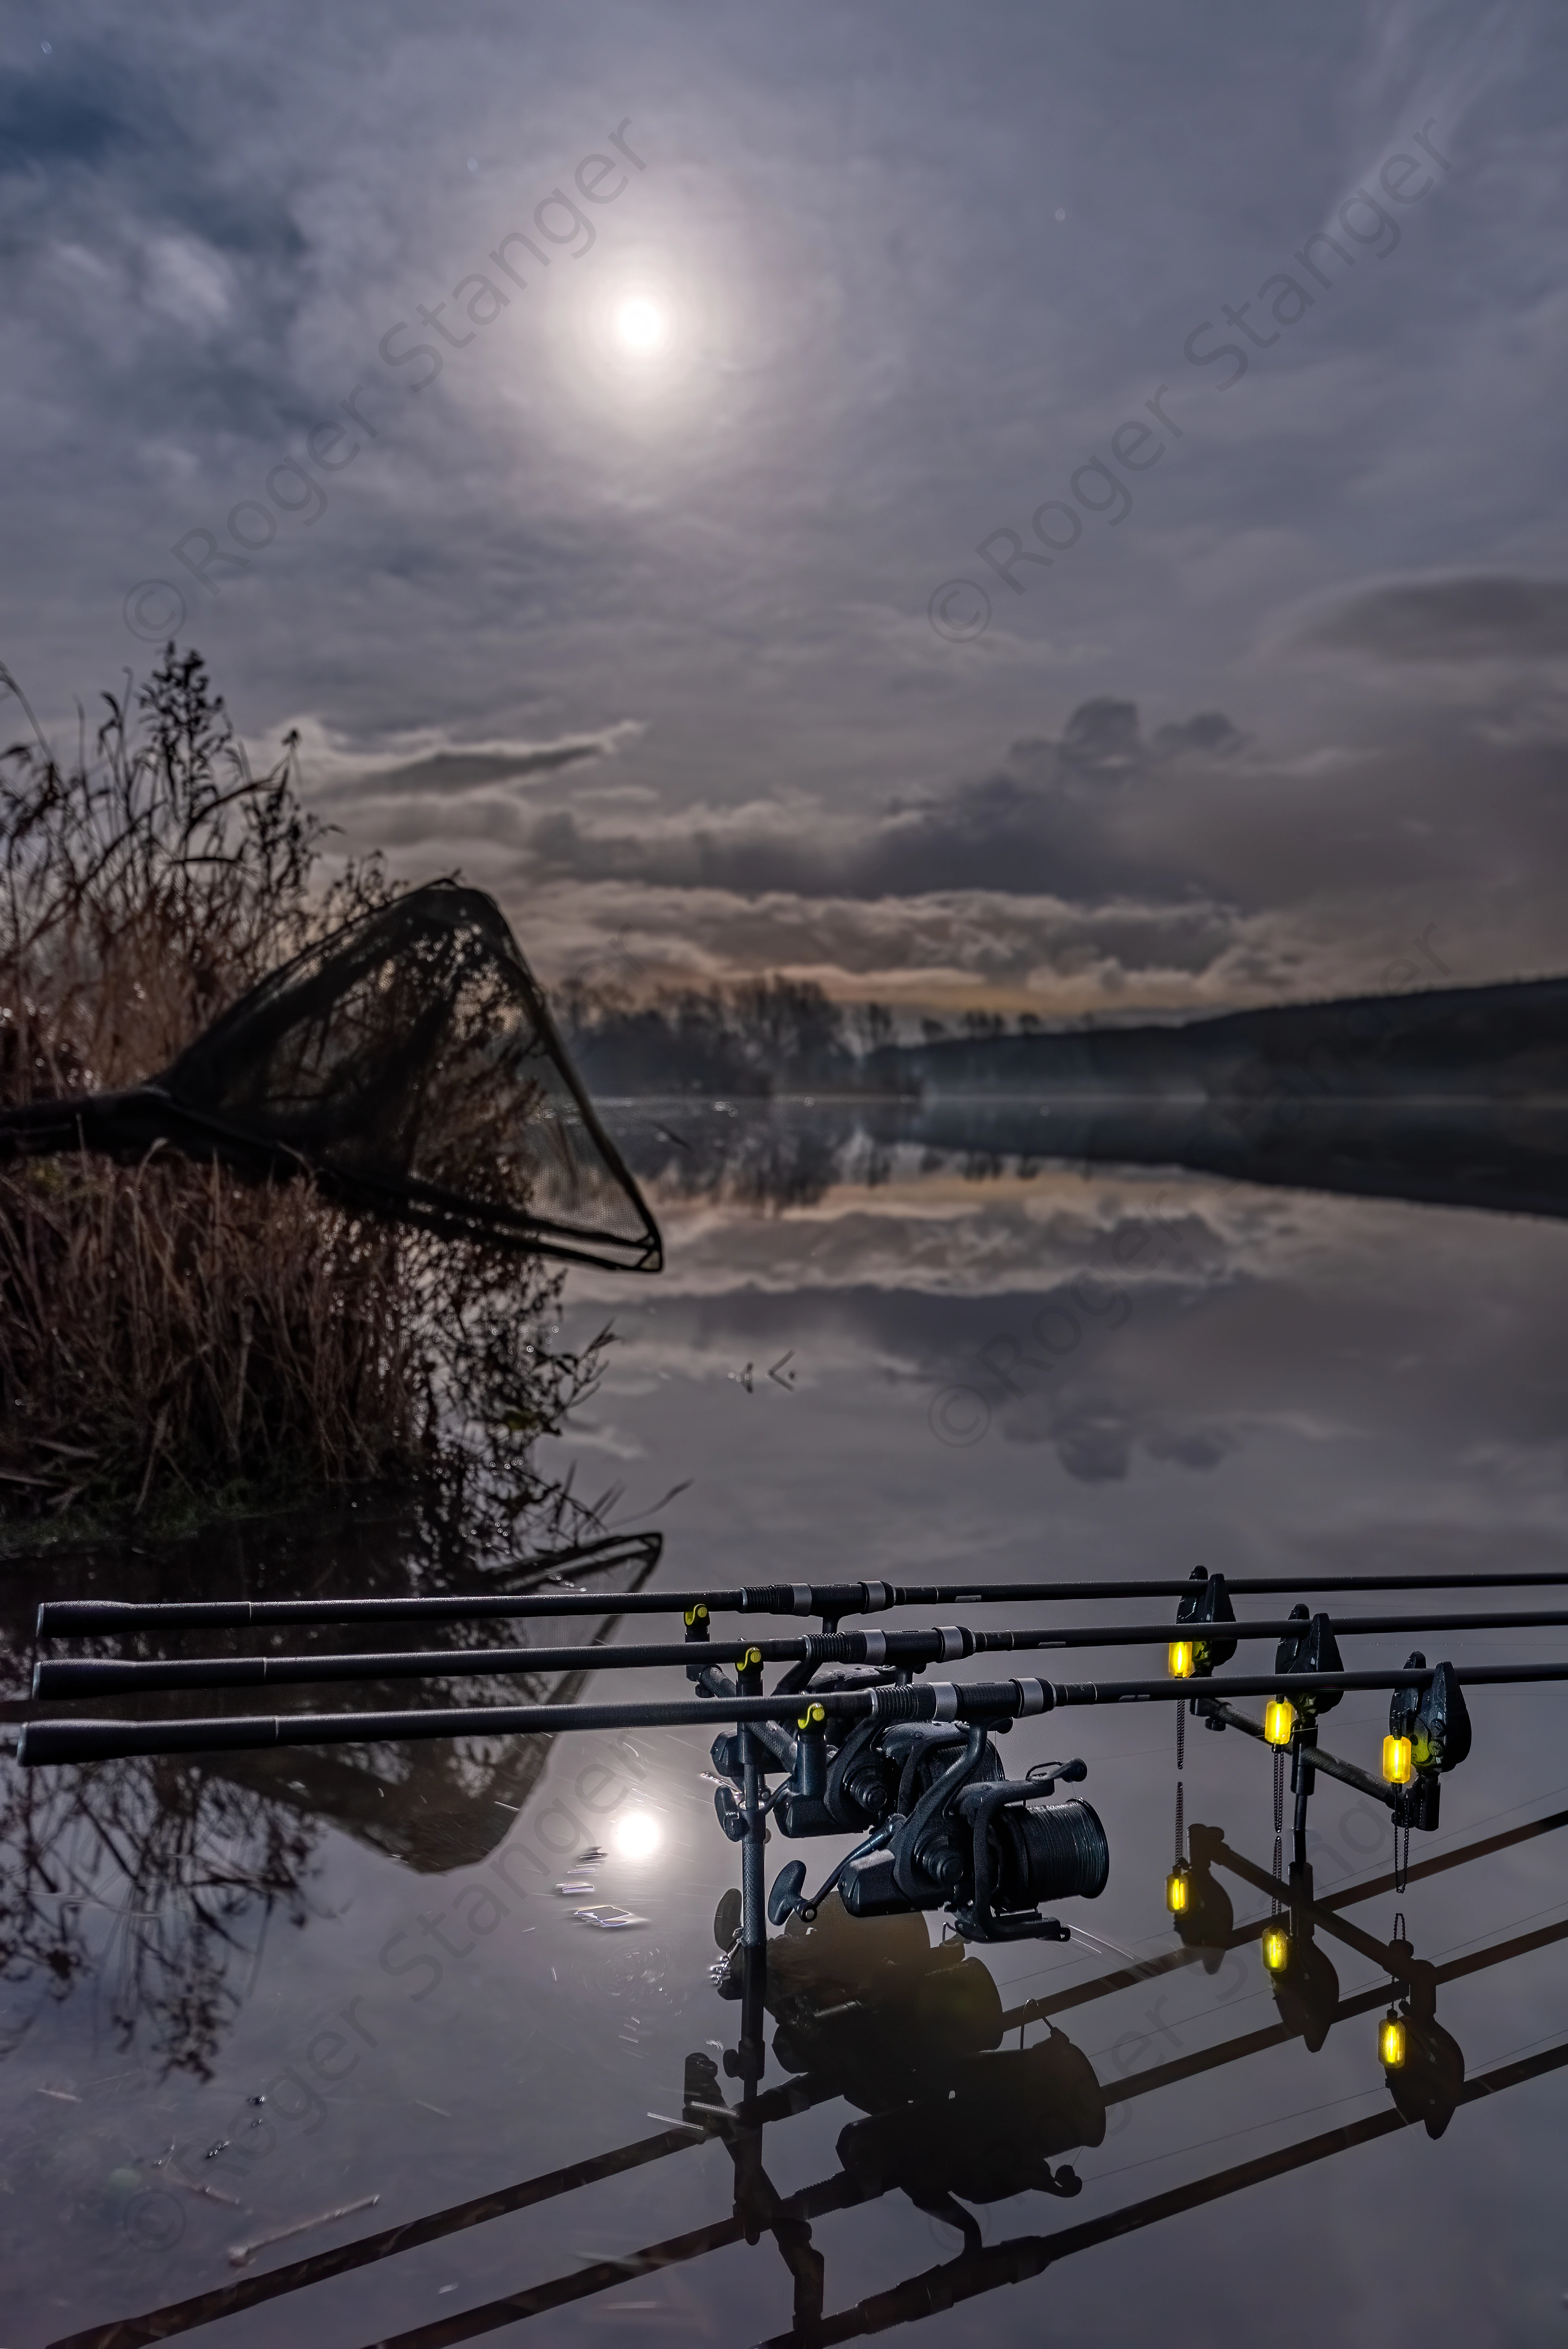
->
[2, 881, 664, 1273]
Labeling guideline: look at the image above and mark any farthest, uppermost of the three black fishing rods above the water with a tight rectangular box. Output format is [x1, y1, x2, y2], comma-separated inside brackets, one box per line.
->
[37, 1534, 1568, 1640]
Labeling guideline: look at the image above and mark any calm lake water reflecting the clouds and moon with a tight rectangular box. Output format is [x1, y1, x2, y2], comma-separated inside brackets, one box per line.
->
[0, 1104, 1568, 2349]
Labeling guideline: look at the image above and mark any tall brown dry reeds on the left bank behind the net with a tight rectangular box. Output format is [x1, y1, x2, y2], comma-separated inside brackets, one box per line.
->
[0, 646, 598, 1541]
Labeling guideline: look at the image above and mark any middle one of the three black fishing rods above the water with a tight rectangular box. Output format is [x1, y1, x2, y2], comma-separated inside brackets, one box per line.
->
[33, 1609, 1568, 1698]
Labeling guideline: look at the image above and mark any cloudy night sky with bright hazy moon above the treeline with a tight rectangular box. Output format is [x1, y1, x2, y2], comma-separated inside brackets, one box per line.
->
[0, 0, 1568, 1012]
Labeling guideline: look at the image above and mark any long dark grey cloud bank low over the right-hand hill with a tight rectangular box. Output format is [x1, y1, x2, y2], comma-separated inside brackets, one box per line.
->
[500, 681, 1568, 944]
